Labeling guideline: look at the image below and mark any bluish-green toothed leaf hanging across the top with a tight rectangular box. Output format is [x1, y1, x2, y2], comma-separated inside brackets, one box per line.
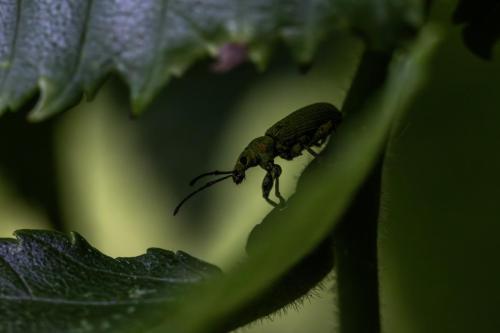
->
[0, 0, 421, 120]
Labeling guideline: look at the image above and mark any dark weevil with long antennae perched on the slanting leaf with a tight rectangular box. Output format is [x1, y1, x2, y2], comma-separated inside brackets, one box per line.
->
[174, 103, 342, 215]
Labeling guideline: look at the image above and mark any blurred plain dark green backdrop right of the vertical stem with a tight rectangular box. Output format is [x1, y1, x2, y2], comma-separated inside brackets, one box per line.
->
[378, 14, 500, 333]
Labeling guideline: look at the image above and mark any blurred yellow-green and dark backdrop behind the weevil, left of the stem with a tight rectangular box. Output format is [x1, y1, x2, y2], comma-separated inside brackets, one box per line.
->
[0, 38, 361, 332]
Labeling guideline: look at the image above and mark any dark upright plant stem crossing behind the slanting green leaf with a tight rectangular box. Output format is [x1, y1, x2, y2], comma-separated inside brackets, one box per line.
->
[334, 50, 391, 333]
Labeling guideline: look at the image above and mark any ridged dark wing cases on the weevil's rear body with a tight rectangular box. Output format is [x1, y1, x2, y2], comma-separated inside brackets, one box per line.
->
[266, 103, 342, 146]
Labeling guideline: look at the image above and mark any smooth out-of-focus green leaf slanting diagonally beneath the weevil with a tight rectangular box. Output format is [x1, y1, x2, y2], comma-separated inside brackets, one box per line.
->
[150, 22, 439, 333]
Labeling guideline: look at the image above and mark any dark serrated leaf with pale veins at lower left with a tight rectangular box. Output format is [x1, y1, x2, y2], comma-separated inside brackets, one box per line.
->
[0, 230, 220, 333]
